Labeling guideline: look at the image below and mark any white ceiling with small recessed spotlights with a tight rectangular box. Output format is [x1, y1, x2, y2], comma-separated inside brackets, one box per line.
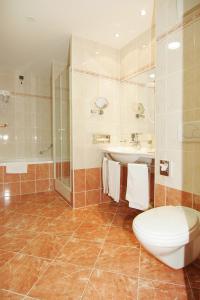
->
[0, 0, 154, 77]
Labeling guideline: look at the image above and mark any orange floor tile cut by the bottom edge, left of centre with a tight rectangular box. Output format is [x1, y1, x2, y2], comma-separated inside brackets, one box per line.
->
[29, 261, 91, 300]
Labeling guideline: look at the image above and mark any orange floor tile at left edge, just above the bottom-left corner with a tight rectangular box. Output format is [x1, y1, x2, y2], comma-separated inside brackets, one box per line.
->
[0, 254, 48, 294]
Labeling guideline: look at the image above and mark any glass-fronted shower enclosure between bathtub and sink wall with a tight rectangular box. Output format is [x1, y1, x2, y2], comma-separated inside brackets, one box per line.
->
[52, 64, 71, 202]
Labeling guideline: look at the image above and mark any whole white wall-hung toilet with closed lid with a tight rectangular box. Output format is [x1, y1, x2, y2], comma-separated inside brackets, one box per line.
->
[133, 206, 200, 269]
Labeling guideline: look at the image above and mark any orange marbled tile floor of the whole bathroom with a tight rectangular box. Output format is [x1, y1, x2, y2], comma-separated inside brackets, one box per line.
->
[0, 192, 200, 300]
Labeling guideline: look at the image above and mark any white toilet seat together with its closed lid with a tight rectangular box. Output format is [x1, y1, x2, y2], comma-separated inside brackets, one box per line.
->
[133, 206, 200, 247]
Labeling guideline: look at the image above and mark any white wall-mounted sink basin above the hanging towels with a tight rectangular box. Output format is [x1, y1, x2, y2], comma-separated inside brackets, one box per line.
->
[102, 146, 155, 164]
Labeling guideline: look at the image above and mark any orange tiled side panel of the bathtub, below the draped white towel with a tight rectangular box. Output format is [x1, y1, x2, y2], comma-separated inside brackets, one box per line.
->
[0, 163, 54, 197]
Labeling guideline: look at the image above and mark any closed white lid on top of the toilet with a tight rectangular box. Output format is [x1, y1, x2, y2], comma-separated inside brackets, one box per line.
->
[133, 206, 199, 240]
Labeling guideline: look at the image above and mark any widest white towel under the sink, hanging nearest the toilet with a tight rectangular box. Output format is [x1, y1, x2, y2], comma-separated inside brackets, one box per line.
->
[126, 164, 149, 210]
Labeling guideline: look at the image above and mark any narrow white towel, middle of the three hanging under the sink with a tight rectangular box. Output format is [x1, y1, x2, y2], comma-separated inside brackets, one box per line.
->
[108, 160, 120, 202]
